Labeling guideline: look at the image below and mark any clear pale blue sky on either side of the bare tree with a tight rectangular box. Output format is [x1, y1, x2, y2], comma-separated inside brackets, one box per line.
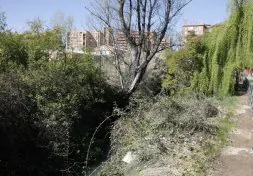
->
[0, 0, 229, 31]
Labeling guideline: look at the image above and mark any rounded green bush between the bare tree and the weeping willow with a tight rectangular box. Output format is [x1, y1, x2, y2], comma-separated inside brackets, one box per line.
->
[163, 35, 204, 95]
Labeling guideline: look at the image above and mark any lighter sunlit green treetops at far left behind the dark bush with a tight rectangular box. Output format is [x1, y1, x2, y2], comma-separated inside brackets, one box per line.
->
[0, 27, 62, 70]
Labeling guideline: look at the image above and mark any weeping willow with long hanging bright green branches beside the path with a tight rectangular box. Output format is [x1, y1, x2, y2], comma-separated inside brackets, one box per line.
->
[192, 0, 253, 95]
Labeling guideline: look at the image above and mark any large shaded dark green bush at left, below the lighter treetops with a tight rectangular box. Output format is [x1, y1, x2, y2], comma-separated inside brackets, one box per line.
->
[0, 55, 117, 175]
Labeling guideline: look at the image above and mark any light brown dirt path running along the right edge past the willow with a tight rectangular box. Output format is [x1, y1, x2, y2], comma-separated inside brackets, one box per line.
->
[209, 95, 253, 176]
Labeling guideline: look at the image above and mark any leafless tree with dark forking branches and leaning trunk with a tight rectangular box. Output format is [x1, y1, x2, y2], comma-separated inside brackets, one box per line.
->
[88, 0, 192, 96]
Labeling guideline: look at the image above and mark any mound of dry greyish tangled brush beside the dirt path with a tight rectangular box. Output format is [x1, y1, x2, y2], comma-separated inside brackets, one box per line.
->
[100, 94, 235, 175]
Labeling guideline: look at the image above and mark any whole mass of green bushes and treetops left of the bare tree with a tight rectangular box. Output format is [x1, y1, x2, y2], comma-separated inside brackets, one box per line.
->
[0, 28, 120, 175]
